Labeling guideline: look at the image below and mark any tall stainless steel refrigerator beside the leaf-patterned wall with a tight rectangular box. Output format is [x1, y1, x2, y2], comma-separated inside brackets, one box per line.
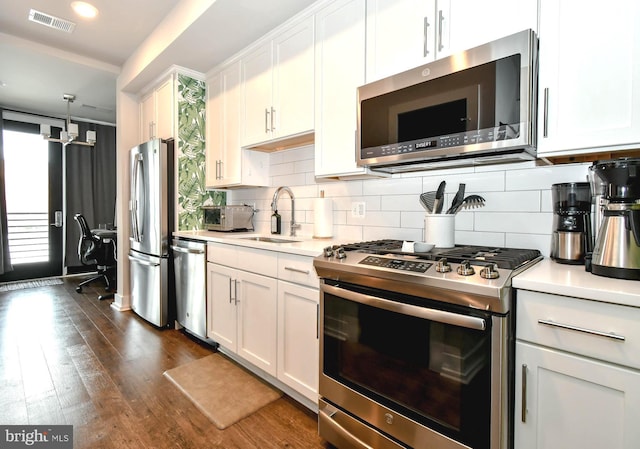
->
[129, 139, 175, 327]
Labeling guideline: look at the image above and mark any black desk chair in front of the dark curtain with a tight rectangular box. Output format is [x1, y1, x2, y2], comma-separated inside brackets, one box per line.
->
[73, 214, 116, 300]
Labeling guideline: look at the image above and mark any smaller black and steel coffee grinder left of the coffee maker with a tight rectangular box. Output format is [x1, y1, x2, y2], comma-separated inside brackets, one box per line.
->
[551, 182, 593, 265]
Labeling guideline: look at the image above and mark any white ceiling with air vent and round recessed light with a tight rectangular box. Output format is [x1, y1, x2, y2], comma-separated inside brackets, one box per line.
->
[0, 0, 315, 123]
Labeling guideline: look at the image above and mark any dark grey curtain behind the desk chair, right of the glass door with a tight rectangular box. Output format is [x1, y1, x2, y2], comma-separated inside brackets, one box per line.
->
[65, 121, 116, 271]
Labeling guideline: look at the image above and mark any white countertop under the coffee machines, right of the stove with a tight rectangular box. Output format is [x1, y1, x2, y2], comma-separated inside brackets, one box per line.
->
[513, 258, 640, 307]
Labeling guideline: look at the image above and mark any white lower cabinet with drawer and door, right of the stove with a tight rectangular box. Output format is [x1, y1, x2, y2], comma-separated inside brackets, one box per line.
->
[514, 290, 640, 449]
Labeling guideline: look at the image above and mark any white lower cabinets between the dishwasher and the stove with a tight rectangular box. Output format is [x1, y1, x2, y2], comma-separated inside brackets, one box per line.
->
[207, 243, 319, 407]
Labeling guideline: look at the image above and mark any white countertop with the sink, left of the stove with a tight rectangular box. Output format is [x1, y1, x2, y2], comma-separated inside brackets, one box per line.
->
[173, 231, 344, 257]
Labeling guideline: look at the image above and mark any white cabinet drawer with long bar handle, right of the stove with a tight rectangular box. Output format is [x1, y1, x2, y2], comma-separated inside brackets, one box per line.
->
[516, 290, 640, 369]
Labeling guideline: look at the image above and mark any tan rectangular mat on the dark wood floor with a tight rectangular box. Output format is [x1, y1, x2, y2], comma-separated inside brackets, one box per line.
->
[164, 353, 282, 429]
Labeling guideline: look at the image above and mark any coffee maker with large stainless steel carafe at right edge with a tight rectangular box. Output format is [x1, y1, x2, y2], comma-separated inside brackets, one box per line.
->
[591, 158, 640, 280]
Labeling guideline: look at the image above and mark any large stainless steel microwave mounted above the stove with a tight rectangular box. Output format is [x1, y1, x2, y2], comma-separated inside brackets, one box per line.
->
[356, 30, 538, 173]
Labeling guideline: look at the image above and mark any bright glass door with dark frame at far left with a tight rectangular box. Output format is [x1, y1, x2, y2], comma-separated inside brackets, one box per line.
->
[0, 120, 63, 282]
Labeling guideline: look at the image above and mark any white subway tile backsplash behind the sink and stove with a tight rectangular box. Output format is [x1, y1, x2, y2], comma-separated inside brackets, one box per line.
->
[228, 145, 590, 255]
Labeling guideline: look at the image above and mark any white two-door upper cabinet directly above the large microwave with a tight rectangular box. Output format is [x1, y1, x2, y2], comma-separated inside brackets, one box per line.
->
[367, 0, 538, 82]
